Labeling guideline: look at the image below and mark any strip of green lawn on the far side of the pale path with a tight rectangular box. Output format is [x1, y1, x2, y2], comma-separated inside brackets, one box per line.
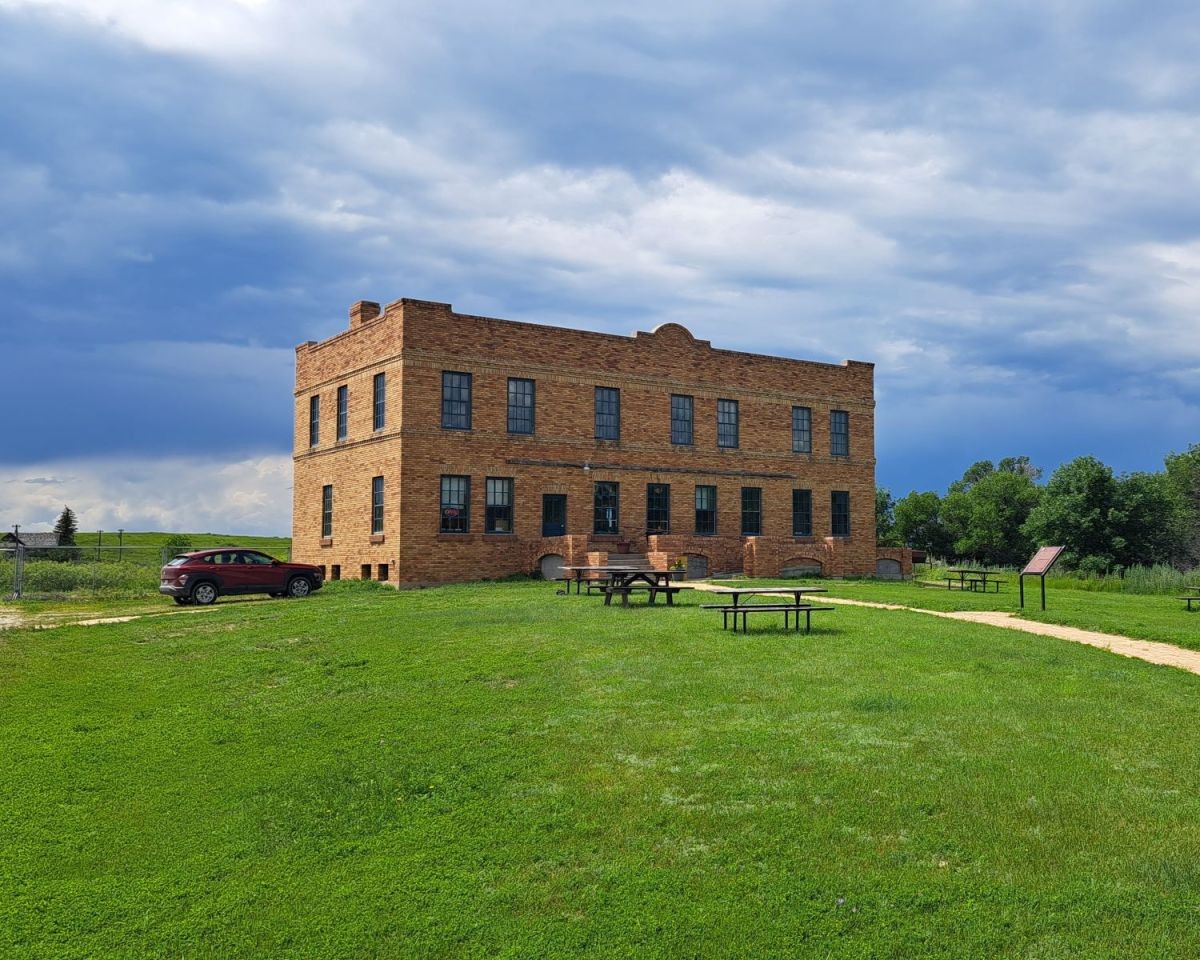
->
[820, 580, 1200, 650]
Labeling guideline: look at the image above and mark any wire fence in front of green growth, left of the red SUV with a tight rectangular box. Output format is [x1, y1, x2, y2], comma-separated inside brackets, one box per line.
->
[0, 544, 288, 600]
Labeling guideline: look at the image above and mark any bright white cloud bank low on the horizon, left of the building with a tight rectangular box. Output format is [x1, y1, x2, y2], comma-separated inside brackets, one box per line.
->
[0, 455, 292, 535]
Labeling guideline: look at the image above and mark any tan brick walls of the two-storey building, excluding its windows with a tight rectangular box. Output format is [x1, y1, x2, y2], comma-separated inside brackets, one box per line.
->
[293, 300, 876, 583]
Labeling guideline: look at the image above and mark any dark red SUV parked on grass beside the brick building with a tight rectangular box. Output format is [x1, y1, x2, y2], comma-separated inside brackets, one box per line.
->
[158, 547, 325, 606]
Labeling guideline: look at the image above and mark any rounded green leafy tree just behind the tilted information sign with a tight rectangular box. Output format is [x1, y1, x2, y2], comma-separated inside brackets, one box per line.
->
[1025, 457, 1126, 571]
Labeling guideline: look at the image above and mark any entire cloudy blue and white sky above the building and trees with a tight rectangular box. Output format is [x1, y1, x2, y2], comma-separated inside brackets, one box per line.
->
[0, 0, 1200, 533]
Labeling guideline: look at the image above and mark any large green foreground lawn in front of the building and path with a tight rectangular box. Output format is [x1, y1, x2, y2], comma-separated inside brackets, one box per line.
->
[0, 582, 1200, 960]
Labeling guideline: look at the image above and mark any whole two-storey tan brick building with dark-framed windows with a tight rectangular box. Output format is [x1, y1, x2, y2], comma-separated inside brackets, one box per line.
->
[292, 299, 908, 584]
